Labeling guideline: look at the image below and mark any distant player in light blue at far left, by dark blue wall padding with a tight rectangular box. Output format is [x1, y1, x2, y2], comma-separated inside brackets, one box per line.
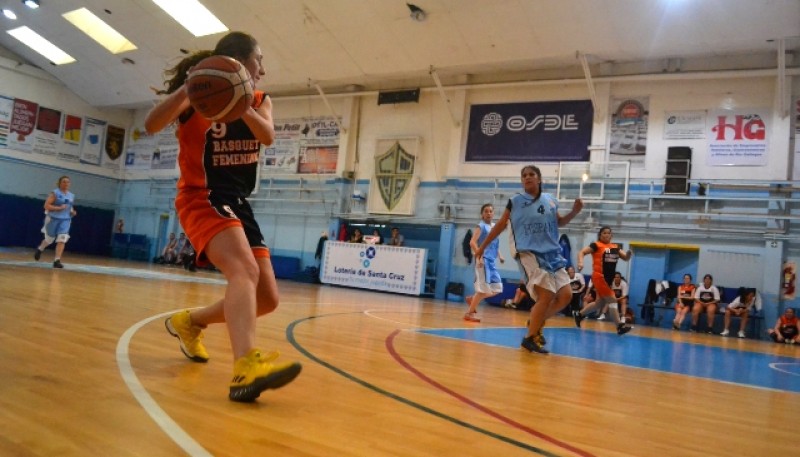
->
[33, 176, 78, 268]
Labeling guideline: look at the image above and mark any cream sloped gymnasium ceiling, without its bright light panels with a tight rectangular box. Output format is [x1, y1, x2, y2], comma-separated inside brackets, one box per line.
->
[0, 0, 800, 108]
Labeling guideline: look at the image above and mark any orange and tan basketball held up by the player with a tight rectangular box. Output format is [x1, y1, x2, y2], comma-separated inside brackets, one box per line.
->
[186, 56, 253, 123]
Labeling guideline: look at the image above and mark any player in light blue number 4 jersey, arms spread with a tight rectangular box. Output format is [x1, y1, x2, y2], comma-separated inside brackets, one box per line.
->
[475, 165, 583, 354]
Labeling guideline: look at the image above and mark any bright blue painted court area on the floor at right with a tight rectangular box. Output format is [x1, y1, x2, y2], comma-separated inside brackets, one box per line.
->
[418, 328, 800, 392]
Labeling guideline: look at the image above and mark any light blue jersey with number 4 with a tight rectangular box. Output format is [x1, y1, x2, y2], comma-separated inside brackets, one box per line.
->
[506, 193, 567, 272]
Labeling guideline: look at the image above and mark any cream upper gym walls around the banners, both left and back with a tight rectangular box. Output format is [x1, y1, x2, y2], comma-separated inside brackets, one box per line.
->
[0, 57, 800, 187]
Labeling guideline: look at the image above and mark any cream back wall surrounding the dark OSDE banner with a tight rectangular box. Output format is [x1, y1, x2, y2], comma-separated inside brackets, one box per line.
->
[262, 72, 791, 185]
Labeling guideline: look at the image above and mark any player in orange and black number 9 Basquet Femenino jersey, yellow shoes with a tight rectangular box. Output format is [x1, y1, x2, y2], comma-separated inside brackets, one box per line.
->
[145, 32, 302, 402]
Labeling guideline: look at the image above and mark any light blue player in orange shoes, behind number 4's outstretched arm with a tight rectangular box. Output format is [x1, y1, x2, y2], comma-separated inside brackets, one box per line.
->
[464, 203, 505, 322]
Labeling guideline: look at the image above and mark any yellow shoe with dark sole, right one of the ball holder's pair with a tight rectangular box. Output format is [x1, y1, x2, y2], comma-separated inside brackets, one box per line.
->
[228, 349, 303, 402]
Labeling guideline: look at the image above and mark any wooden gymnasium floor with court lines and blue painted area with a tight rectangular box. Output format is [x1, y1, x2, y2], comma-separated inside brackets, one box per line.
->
[0, 249, 800, 457]
